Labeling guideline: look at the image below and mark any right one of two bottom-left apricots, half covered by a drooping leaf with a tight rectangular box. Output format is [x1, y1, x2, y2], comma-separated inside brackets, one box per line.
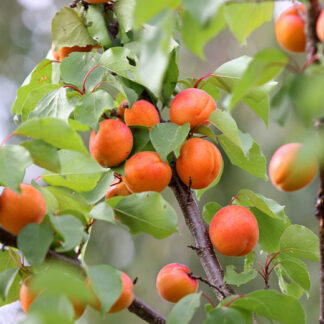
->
[87, 272, 134, 314]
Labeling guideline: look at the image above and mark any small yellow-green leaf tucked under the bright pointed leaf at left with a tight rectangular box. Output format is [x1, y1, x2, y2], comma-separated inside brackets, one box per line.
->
[44, 187, 90, 213]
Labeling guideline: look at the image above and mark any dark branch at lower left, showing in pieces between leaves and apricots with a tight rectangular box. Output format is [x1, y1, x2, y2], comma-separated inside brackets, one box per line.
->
[0, 227, 165, 324]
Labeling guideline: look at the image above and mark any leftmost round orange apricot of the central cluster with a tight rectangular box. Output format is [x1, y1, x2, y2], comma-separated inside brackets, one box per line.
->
[89, 119, 133, 167]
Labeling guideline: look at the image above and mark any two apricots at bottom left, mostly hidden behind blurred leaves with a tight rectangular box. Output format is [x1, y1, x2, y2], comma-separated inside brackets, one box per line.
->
[20, 272, 134, 319]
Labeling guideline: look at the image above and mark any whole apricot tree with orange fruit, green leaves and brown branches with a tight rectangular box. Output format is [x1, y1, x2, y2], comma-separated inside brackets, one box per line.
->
[0, 0, 324, 324]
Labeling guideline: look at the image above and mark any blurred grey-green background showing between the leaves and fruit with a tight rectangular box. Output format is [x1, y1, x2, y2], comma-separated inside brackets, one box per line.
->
[0, 0, 319, 324]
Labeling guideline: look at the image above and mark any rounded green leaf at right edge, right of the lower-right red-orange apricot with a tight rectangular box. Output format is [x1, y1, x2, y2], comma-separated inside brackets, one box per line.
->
[280, 225, 319, 261]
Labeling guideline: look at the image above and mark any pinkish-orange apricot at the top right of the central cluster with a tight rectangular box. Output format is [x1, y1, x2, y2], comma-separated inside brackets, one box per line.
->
[170, 88, 217, 128]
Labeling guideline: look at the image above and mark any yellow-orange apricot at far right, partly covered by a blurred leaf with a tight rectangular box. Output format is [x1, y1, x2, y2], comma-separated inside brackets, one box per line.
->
[269, 143, 317, 191]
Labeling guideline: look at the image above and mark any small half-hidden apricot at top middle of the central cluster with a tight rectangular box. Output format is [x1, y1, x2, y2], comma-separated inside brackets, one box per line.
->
[124, 100, 160, 127]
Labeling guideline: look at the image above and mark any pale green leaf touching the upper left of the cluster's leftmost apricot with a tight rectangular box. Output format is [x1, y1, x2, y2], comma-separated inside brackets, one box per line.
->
[74, 89, 114, 129]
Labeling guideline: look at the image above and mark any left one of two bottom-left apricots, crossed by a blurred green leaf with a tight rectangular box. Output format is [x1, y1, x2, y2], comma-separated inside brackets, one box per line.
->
[19, 276, 86, 319]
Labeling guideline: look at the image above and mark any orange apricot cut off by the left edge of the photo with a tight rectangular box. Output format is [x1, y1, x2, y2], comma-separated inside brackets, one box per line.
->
[0, 183, 46, 235]
